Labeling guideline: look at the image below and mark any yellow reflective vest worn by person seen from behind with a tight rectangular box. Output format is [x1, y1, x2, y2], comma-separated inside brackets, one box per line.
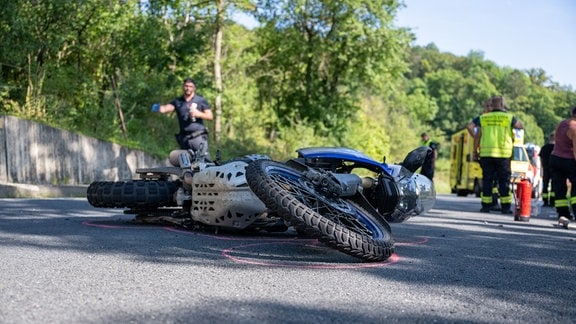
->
[480, 111, 514, 158]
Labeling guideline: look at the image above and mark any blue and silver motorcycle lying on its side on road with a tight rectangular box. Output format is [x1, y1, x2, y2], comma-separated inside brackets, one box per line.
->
[87, 147, 436, 261]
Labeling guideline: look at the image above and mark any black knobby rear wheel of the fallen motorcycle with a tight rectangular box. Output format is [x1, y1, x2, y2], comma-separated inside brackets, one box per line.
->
[86, 180, 178, 208]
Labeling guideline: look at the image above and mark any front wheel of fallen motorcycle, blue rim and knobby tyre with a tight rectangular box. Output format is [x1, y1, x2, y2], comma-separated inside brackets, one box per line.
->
[246, 160, 394, 262]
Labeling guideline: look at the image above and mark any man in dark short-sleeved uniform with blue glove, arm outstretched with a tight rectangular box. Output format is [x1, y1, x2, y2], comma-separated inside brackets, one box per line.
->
[152, 78, 214, 152]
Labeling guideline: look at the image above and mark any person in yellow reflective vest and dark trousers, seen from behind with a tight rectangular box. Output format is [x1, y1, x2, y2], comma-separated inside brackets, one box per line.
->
[474, 96, 523, 214]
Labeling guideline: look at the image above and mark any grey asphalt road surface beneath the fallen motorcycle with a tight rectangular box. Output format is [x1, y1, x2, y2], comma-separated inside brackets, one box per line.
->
[0, 195, 576, 323]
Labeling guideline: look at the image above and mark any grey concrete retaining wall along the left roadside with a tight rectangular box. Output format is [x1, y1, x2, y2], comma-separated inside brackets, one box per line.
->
[0, 116, 169, 185]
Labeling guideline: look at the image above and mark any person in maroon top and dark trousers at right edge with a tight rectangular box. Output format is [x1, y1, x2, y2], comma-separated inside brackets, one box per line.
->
[550, 106, 576, 228]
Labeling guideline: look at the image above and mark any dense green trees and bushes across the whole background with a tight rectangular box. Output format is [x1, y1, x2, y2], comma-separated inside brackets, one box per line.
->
[0, 0, 576, 189]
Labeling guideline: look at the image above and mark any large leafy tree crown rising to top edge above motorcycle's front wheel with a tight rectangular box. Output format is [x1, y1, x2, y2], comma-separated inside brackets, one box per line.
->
[254, 0, 408, 139]
